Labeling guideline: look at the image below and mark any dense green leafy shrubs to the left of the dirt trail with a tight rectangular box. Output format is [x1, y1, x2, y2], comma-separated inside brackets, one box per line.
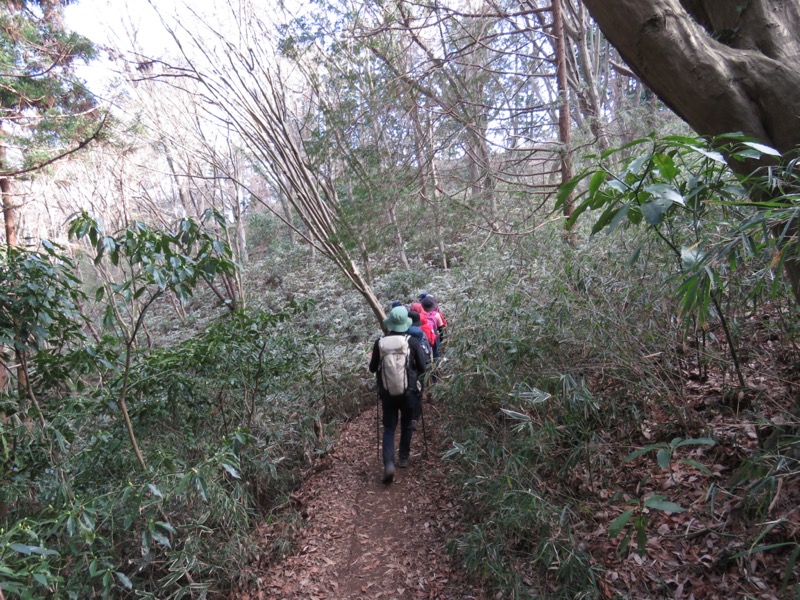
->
[0, 214, 372, 599]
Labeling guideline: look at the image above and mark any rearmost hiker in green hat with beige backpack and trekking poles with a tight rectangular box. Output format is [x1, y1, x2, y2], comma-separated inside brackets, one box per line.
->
[369, 306, 425, 483]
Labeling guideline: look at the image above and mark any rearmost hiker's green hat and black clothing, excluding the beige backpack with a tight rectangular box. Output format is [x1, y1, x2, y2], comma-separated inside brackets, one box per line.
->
[369, 306, 425, 483]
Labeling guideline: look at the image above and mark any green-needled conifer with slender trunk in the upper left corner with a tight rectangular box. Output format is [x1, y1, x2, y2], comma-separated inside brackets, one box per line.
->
[0, 0, 99, 246]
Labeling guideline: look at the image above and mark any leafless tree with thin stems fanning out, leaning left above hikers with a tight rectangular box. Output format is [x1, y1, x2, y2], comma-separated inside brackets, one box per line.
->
[150, 2, 385, 323]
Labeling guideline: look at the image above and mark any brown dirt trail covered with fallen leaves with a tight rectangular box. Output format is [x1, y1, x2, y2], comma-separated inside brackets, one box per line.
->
[239, 402, 483, 600]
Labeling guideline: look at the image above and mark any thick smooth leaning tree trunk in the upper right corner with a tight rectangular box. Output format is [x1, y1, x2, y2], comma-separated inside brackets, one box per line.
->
[584, 0, 800, 302]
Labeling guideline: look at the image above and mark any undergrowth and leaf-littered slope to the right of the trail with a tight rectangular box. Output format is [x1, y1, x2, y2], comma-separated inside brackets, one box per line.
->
[435, 139, 800, 598]
